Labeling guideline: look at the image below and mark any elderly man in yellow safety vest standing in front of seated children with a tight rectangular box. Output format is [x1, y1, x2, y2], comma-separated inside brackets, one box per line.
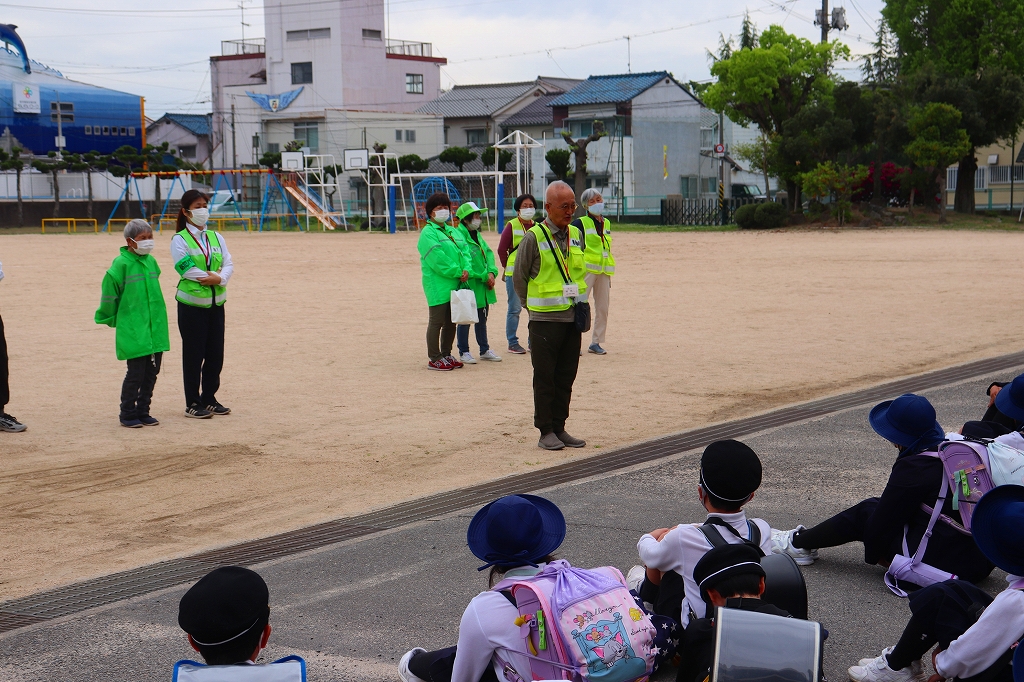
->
[512, 180, 587, 450]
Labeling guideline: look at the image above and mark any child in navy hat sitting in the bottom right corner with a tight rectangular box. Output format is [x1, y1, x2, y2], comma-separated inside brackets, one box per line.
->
[849, 485, 1024, 682]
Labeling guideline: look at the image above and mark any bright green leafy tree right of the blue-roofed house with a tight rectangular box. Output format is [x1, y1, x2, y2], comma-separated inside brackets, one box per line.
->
[702, 26, 850, 210]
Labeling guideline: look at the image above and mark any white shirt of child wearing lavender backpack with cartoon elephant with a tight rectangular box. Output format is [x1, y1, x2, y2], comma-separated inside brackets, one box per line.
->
[452, 563, 545, 682]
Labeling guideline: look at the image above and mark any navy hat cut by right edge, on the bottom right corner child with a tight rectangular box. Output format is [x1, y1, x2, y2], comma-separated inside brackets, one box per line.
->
[971, 485, 1024, 577]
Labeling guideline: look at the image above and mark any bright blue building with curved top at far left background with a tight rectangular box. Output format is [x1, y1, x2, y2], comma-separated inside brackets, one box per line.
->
[0, 24, 145, 155]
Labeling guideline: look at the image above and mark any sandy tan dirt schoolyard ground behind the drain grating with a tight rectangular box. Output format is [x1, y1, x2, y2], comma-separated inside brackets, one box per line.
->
[0, 229, 1024, 600]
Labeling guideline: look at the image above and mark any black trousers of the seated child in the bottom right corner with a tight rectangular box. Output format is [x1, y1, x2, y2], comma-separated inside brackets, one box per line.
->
[887, 581, 1013, 682]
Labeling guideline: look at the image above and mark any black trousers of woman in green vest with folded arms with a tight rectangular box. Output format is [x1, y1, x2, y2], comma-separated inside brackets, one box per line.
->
[178, 301, 224, 407]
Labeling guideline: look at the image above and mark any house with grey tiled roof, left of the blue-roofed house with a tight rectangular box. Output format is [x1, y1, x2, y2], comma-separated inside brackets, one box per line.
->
[416, 76, 582, 146]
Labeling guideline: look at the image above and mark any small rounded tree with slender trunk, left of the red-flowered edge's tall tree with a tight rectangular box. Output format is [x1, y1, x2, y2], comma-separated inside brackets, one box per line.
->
[906, 102, 971, 222]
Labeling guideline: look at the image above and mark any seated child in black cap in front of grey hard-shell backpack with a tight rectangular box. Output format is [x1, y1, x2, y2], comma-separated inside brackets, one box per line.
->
[676, 544, 790, 682]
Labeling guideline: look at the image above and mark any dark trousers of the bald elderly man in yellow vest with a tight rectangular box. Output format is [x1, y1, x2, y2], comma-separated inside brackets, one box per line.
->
[529, 319, 583, 435]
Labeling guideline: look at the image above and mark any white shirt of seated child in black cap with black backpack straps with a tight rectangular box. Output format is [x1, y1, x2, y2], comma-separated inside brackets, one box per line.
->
[637, 511, 771, 628]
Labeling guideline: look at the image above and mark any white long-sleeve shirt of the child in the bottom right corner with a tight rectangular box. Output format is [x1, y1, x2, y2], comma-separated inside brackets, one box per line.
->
[935, 576, 1024, 679]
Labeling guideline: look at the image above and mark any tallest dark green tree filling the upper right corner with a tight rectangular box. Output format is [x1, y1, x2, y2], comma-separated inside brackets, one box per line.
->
[882, 0, 1024, 213]
